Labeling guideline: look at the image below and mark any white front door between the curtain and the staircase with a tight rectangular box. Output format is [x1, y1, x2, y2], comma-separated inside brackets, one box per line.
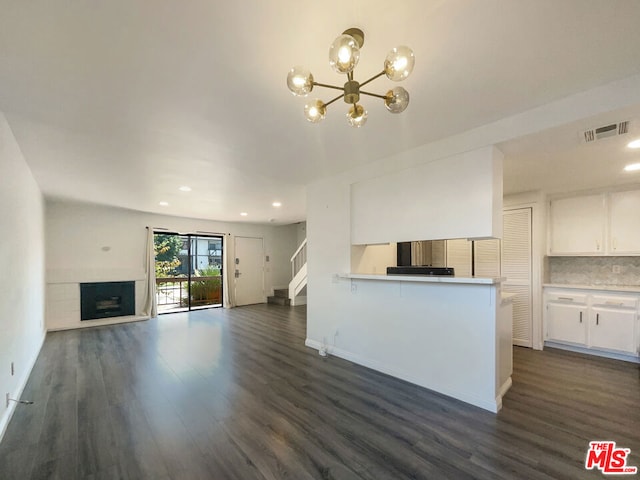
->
[234, 237, 266, 306]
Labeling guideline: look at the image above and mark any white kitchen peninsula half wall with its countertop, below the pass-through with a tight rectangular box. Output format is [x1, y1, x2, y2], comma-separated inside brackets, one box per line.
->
[306, 274, 512, 412]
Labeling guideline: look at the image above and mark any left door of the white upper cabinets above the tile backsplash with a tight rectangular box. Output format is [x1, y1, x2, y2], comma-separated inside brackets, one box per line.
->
[549, 193, 607, 255]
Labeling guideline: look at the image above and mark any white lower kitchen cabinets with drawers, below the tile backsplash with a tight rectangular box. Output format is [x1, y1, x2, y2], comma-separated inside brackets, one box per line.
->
[545, 288, 640, 357]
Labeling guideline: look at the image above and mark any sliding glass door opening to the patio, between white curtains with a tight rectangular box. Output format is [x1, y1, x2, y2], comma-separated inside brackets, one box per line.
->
[154, 233, 222, 313]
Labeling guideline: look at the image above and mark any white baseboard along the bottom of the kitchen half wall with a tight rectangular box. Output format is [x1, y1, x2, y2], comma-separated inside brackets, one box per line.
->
[304, 338, 502, 413]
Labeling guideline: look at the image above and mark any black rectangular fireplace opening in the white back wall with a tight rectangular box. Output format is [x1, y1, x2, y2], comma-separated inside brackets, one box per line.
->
[80, 282, 135, 320]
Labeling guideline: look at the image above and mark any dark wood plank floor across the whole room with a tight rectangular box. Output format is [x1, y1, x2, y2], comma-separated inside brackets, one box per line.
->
[0, 305, 640, 480]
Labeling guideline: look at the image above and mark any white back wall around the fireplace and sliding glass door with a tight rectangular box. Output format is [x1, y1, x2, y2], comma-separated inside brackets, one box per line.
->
[46, 200, 297, 329]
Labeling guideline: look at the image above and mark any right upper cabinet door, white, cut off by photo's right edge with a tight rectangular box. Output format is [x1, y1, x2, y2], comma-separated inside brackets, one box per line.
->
[609, 190, 640, 255]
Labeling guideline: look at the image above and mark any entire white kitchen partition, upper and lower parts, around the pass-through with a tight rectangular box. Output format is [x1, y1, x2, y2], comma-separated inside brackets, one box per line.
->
[305, 145, 512, 412]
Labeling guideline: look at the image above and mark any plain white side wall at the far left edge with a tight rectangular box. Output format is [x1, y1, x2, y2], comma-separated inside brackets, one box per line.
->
[0, 113, 44, 439]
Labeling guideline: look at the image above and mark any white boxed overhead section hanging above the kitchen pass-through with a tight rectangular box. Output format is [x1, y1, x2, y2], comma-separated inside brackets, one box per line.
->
[351, 146, 502, 244]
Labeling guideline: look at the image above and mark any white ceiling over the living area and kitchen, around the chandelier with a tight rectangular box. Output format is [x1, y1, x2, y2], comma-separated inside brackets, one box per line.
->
[0, 0, 640, 224]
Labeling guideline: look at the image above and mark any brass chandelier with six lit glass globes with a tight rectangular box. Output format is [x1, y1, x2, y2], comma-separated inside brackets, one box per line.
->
[287, 28, 415, 128]
